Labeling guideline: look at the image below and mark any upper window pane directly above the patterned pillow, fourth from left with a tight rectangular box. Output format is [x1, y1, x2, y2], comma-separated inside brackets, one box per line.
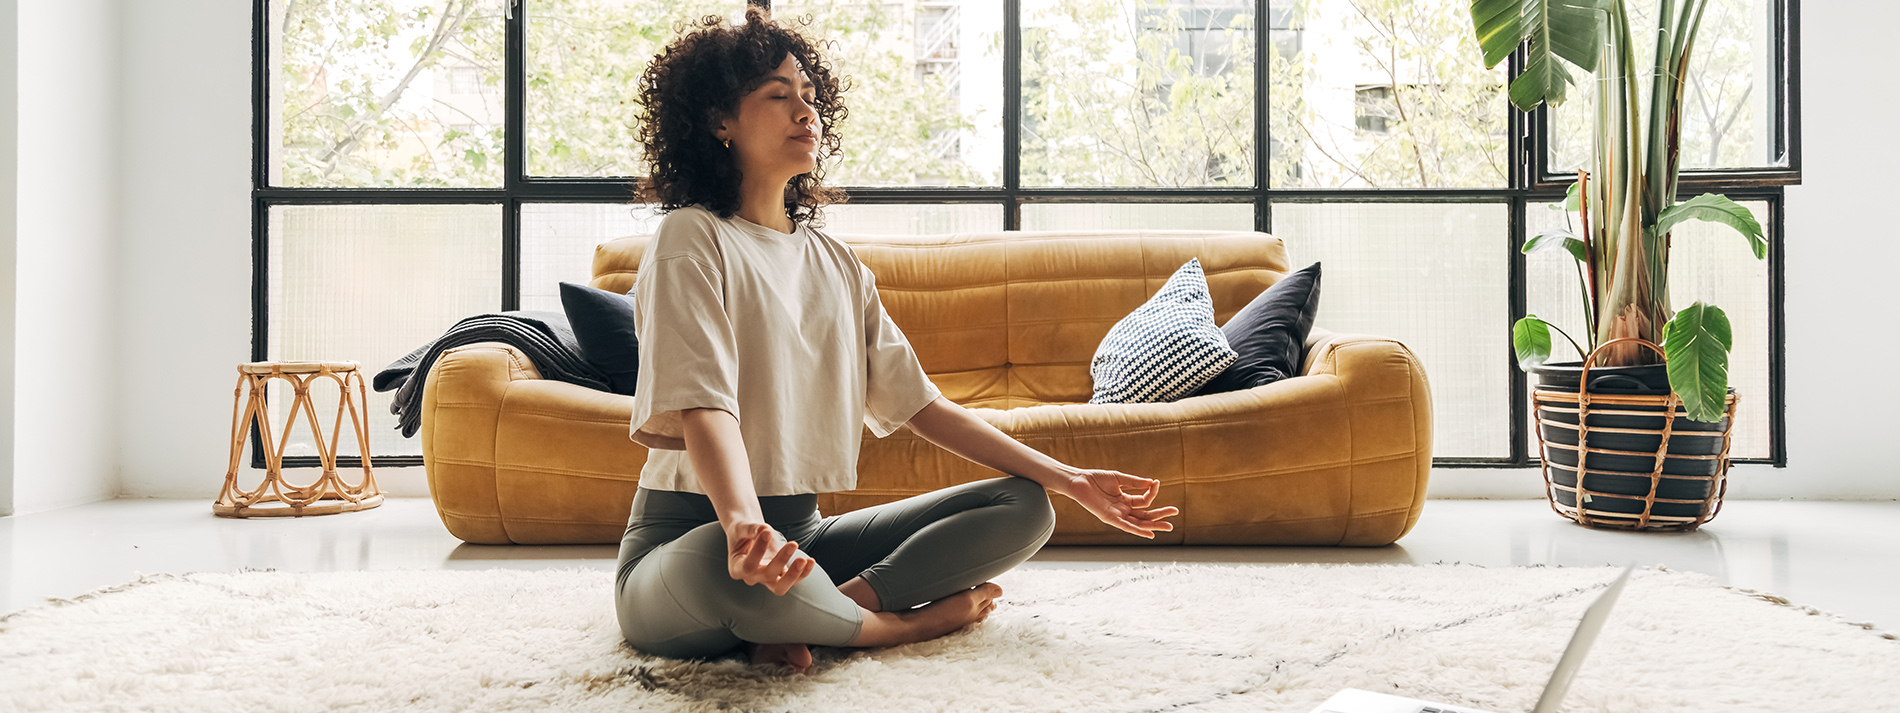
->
[1020, 0, 1254, 186]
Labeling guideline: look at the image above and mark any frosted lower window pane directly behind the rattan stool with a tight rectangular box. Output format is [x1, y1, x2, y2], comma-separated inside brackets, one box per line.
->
[266, 205, 502, 458]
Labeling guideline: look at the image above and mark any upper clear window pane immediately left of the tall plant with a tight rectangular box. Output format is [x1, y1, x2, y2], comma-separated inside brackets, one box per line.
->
[1267, 0, 1511, 188]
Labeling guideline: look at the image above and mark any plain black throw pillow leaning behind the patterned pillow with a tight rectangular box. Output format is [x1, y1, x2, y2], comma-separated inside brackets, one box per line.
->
[1188, 262, 1319, 395]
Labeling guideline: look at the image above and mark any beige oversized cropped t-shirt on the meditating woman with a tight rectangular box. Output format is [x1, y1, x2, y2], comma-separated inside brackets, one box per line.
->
[631, 205, 941, 496]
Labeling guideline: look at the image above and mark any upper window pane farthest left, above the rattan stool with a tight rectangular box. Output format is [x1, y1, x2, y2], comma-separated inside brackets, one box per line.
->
[266, 0, 504, 188]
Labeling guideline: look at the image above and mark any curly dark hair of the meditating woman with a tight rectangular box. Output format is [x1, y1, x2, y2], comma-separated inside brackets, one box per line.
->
[635, 4, 847, 224]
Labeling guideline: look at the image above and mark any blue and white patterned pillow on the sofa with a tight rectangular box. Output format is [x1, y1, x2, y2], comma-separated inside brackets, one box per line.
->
[1089, 257, 1239, 403]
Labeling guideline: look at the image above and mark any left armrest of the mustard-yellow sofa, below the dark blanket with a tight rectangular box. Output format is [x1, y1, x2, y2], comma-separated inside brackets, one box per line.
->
[416, 342, 542, 544]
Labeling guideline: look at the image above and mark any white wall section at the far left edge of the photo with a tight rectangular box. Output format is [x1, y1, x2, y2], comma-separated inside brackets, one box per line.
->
[8, 0, 125, 513]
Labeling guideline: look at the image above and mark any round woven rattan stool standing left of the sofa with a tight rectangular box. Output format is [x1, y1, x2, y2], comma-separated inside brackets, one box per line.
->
[211, 361, 382, 517]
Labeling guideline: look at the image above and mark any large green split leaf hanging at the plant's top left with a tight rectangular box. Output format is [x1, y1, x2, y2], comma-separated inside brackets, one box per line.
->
[1471, 0, 1607, 112]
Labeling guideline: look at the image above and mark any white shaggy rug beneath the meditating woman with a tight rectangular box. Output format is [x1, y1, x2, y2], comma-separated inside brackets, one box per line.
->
[0, 565, 1900, 713]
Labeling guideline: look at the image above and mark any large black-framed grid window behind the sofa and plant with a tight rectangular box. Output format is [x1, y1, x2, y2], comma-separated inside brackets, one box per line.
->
[253, 0, 1801, 468]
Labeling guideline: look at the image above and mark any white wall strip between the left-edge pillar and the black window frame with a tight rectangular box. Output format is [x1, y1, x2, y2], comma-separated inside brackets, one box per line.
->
[116, 0, 319, 510]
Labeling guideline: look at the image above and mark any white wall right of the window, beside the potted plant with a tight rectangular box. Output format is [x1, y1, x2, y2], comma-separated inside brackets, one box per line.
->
[1755, 2, 1900, 500]
